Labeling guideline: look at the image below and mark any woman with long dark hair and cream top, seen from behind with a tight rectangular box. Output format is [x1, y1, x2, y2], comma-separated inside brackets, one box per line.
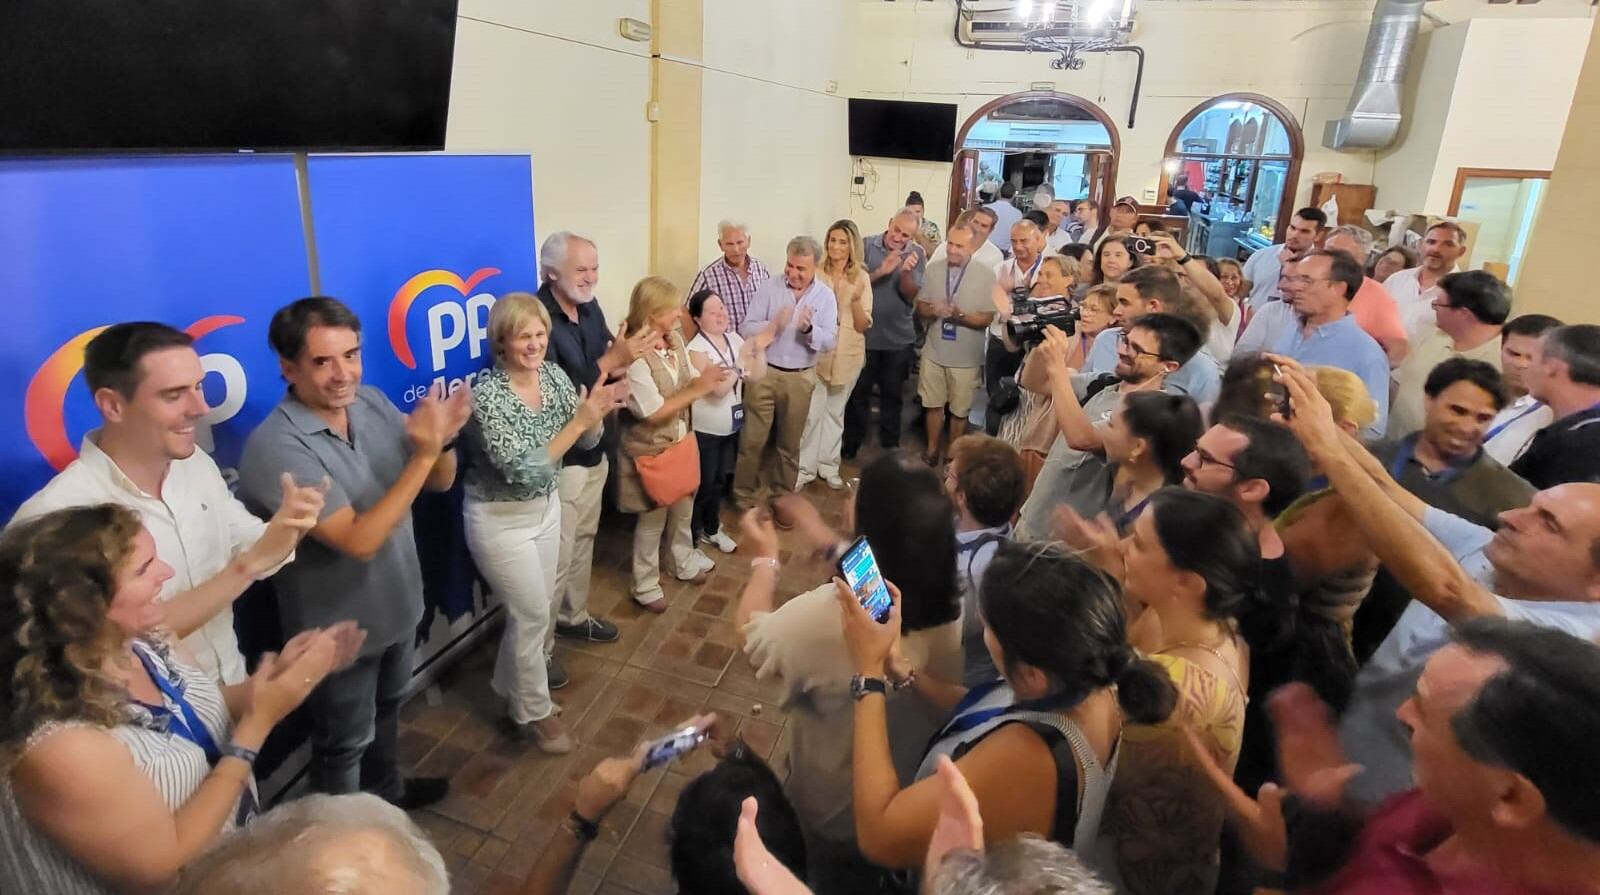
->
[734, 453, 962, 892]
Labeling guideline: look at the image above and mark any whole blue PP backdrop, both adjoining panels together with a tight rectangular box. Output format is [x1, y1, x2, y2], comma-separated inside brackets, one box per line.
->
[0, 155, 538, 520]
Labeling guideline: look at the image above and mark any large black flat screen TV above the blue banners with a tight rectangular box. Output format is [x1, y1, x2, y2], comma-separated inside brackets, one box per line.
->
[0, 0, 458, 154]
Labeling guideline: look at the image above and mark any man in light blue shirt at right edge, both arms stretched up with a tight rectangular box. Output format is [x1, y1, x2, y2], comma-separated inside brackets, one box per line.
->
[1275, 359, 1600, 801]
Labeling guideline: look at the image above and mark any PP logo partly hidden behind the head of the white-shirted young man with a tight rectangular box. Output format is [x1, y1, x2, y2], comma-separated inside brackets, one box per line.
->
[22, 314, 250, 472]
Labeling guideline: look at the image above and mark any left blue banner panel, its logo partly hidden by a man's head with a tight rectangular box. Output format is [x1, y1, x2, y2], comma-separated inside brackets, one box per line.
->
[0, 155, 309, 519]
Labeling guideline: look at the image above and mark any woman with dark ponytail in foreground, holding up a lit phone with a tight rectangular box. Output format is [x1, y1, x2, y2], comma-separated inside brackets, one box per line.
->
[837, 541, 1176, 869]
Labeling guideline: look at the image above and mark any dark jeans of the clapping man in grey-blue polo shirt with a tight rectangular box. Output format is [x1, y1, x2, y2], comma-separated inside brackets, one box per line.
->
[306, 634, 413, 801]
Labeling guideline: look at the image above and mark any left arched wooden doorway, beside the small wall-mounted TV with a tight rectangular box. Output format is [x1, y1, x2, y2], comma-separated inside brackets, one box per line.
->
[950, 90, 1122, 221]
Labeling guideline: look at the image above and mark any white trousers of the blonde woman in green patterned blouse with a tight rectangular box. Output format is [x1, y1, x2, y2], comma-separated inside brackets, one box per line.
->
[464, 495, 562, 724]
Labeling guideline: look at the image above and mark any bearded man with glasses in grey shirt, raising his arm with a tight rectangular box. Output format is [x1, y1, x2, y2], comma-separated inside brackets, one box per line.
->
[1018, 314, 1200, 540]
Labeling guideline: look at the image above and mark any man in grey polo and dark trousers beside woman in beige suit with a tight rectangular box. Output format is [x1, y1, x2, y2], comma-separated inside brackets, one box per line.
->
[840, 208, 928, 460]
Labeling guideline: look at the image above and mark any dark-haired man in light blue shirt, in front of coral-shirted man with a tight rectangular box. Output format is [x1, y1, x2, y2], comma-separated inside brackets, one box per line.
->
[1251, 250, 1389, 439]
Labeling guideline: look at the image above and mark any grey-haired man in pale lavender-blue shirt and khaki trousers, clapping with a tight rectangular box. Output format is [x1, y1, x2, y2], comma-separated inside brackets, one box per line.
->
[733, 237, 838, 518]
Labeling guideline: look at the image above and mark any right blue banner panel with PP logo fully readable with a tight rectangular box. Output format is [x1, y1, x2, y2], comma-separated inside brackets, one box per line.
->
[309, 155, 538, 410]
